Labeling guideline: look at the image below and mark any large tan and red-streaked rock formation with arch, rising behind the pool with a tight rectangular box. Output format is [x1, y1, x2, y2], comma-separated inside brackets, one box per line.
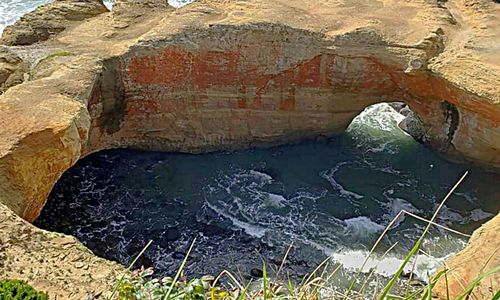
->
[0, 0, 500, 291]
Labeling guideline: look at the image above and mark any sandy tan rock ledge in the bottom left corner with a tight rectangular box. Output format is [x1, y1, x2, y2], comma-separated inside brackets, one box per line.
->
[0, 204, 125, 299]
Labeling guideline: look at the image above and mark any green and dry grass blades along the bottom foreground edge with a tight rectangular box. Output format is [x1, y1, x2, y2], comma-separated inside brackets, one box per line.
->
[104, 173, 500, 300]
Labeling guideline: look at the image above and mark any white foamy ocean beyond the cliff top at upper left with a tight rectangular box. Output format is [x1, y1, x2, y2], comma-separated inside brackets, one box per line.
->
[0, 0, 192, 32]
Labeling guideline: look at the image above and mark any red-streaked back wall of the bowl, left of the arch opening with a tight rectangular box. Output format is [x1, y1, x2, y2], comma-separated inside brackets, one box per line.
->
[89, 24, 406, 152]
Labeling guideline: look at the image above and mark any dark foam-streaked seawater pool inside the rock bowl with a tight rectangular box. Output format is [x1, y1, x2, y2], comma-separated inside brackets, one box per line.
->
[36, 104, 500, 285]
